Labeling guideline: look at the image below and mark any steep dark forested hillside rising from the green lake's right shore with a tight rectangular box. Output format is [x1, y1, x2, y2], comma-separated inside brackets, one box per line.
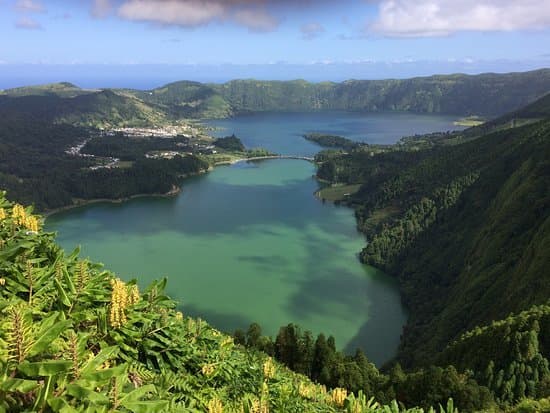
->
[319, 100, 550, 367]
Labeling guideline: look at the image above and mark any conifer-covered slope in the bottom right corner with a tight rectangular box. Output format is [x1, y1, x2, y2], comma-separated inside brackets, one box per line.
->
[439, 301, 550, 402]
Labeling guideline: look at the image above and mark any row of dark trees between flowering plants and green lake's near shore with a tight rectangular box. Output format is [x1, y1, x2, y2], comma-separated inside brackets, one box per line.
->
[234, 323, 496, 411]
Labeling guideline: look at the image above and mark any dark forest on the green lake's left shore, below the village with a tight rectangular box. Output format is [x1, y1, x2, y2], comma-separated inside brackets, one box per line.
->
[0, 117, 209, 211]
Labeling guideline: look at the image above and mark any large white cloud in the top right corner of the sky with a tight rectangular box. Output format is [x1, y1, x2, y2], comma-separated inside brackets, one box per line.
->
[370, 0, 550, 37]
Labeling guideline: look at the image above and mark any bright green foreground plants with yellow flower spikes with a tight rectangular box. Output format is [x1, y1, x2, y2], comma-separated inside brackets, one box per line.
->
[0, 194, 470, 413]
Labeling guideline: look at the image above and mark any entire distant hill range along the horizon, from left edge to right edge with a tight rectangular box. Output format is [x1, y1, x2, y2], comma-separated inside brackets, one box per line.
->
[0, 69, 550, 124]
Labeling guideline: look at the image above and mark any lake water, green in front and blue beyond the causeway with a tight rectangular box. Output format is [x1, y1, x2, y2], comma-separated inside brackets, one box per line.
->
[46, 113, 466, 364]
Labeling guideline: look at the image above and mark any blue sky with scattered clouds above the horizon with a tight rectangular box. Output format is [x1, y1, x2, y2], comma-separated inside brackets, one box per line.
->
[0, 0, 550, 87]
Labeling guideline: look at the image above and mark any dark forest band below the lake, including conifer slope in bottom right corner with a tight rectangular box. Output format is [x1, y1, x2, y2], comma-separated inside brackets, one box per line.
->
[234, 301, 550, 411]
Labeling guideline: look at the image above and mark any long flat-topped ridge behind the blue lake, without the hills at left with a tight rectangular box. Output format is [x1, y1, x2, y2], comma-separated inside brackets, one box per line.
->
[133, 69, 550, 117]
